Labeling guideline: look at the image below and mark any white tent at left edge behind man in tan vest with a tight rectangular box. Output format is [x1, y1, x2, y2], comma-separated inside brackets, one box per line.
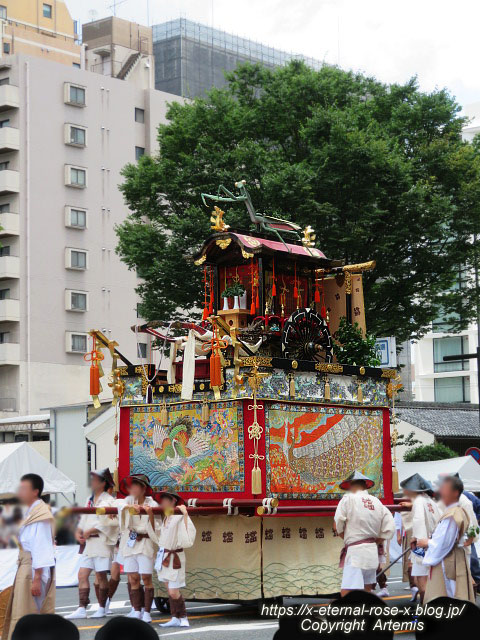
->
[0, 442, 76, 498]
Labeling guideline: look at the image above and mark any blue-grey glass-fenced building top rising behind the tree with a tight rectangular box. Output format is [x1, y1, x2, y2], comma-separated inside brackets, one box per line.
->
[152, 18, 322, 98]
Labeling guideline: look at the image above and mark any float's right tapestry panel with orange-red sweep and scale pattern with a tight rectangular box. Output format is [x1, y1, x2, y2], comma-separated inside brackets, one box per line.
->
[265, 403, 383, 500]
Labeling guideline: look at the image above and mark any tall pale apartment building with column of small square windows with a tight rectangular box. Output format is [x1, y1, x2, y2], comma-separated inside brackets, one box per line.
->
[0, 19, 179, 418]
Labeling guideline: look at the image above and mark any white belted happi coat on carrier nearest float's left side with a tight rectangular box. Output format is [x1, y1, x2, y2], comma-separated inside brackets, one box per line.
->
[149, 514, 196, 583]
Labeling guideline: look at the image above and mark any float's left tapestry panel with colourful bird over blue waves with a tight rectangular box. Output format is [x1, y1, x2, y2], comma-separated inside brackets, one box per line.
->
[130, 402, 244, 492]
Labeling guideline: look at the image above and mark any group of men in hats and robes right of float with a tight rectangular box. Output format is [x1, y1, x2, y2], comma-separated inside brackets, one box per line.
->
[335, 471, 480, 602]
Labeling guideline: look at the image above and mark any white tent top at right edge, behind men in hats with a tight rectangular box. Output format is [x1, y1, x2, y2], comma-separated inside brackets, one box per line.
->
[397, 456, 480, 491]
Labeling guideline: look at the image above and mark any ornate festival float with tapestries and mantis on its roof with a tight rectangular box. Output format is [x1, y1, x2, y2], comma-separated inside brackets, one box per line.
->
[83, 182, 397, 601]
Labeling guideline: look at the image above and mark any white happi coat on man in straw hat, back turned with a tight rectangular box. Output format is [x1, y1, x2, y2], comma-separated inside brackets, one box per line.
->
[335, 491, 395, 569]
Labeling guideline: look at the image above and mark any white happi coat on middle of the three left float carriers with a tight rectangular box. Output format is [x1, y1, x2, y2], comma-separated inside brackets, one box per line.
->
[115, 496, 158, 558]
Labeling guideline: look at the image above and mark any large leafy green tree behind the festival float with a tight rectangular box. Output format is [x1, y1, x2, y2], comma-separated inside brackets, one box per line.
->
[117, 62, 480, 340]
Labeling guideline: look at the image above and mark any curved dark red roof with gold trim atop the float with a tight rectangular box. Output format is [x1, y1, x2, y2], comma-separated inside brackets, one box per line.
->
[194, 232, 344, 268]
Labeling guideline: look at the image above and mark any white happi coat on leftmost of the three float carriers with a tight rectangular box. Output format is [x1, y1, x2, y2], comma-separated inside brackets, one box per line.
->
[78, 491, 118, 558]
